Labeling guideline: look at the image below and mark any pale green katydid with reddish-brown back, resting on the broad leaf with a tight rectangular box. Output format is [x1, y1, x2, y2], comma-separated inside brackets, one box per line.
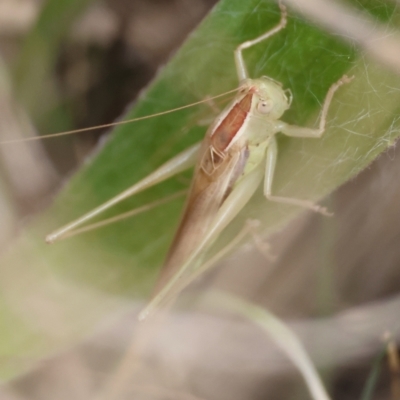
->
[40, 3, 352, 319]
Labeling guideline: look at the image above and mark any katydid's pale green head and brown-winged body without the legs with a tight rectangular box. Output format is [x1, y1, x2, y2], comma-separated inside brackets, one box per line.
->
[153, 77, 290, 294]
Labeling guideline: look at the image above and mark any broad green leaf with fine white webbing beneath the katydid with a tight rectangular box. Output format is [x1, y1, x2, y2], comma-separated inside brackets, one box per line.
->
[0, 0, 400, 378]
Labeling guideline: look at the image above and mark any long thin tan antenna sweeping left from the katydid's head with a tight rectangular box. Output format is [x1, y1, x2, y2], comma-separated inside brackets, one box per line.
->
[0, 88, 238, 145]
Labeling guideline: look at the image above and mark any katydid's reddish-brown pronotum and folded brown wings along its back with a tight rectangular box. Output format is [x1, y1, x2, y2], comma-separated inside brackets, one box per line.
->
[155, 92, 252, 294]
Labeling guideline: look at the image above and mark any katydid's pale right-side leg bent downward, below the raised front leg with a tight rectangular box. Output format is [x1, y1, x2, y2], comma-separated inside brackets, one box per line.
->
[264, 137, 331, 215]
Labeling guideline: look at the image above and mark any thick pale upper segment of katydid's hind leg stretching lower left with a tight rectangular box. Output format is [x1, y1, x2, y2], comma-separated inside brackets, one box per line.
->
[46, 143, 200, 243]
